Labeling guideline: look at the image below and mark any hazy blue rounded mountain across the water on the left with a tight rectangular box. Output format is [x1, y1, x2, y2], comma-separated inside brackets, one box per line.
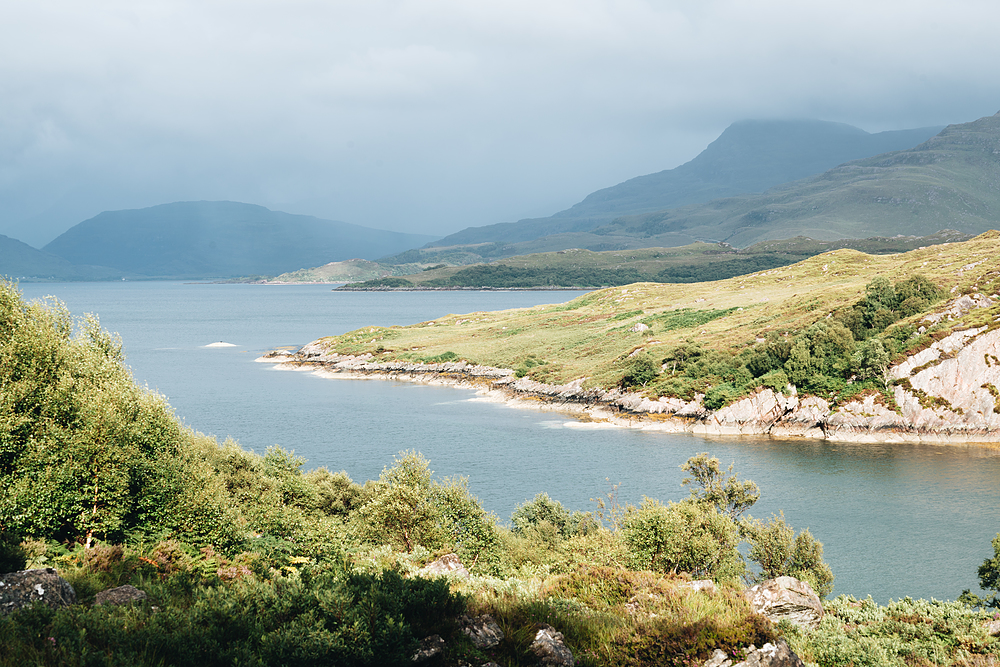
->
[44, 201, 434, 278]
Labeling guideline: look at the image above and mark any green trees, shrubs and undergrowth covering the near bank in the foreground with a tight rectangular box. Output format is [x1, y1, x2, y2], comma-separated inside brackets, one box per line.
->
[0, 285, 1000, 665]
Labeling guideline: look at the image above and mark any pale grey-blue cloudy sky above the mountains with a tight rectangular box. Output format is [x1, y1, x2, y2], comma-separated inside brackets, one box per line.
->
[0, 0, 1000, 247]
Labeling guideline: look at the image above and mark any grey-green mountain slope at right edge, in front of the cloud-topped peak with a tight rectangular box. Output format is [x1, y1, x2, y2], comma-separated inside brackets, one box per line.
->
[593, 113, 1000, 247]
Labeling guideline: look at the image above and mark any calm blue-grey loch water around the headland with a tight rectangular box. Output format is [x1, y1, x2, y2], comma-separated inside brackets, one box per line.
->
[20, 282, 1000, 603]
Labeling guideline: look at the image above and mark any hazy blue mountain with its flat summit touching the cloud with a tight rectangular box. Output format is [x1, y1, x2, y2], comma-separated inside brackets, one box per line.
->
[429, 120, 941, 247]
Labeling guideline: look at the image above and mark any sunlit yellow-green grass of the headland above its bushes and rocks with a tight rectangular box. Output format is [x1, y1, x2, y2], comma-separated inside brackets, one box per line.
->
[312, 232, 1000, 386]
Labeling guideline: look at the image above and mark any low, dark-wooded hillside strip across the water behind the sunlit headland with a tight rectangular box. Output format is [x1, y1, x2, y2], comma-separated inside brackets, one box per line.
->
[342, 230, 971, 290]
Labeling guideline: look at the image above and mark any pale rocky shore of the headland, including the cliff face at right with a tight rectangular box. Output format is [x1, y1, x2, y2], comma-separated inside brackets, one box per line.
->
[257, 316, 1000, 444]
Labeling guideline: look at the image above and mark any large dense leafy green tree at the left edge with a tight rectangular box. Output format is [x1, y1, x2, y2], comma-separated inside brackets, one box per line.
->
[0, 284, 184, 546]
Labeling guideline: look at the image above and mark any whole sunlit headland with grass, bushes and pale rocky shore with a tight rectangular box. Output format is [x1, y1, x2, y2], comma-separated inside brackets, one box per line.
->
[288, 231, 1000, 441]
